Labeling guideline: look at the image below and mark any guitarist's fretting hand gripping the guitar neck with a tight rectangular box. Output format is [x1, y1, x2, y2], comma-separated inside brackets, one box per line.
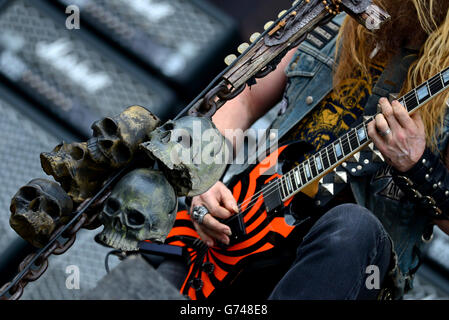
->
[368, 98, 426, 172]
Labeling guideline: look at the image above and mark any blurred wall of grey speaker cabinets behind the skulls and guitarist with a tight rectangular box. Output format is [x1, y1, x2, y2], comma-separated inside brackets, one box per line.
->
[0, 0, 449, 299]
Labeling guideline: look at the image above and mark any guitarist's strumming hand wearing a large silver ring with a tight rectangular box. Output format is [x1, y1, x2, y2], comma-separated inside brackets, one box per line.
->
[190, 181, 239, 247]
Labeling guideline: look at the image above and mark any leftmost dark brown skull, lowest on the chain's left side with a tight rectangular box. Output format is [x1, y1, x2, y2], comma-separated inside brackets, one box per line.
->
[9, 179, 73, 248]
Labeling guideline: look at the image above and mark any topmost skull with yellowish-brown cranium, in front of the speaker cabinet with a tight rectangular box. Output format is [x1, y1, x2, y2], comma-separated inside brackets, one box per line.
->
[88, 106, 160, 168]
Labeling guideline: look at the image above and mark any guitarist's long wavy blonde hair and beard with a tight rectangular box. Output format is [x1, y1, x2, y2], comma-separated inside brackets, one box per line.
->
[334, 0, 449, 150]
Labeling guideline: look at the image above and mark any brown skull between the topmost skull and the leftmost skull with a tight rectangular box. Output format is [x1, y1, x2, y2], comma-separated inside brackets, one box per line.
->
[41, 142, 108, 203]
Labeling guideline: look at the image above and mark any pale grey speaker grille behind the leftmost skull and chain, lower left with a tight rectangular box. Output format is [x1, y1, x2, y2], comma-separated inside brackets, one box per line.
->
[0, 95, 117, 299]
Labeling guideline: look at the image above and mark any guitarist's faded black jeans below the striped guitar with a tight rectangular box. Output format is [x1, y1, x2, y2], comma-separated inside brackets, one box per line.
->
[158, 204, 391, 300]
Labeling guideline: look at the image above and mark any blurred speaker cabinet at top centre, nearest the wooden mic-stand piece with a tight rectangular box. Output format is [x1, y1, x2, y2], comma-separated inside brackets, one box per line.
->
[50, 0, 239, 99]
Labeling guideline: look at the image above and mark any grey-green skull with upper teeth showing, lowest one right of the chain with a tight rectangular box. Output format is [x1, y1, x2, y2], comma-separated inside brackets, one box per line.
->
[95, 169, 178, 251]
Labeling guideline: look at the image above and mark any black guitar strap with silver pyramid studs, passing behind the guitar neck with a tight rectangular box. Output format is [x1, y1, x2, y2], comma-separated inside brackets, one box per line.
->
[315, 48, 417, 206]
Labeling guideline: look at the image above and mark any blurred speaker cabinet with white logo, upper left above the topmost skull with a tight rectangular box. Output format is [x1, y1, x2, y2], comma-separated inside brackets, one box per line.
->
[0, 0, 175, 137]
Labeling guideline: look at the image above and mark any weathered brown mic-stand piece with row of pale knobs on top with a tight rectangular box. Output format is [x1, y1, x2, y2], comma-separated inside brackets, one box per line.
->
[189, 0, 390, 117]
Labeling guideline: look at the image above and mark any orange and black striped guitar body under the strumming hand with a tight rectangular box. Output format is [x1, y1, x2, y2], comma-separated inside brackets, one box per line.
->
[165, 144, 316, 300]
